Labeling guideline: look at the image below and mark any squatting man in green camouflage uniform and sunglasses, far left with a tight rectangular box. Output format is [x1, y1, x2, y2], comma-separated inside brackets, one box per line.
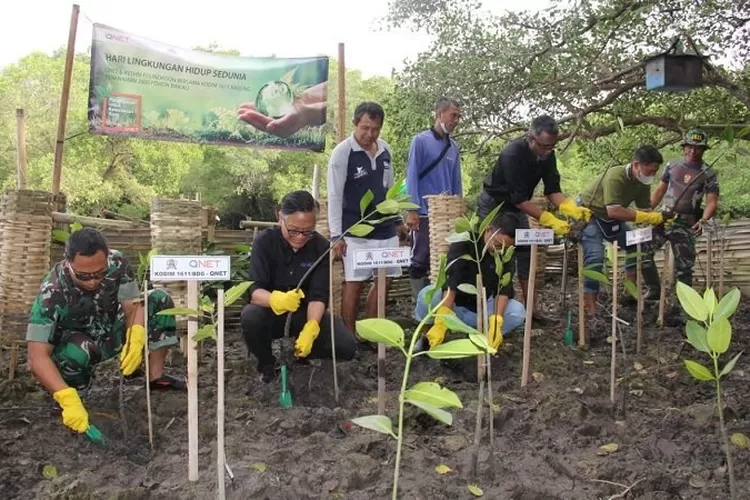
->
[26, 228, 185, 433]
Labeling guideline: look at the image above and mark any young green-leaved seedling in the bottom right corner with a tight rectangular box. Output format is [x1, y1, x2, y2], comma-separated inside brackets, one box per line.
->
[677, 281, 742, 500]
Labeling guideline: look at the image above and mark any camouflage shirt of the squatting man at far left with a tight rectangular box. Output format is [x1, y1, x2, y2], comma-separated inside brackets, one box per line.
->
[26, 250, 139, 345]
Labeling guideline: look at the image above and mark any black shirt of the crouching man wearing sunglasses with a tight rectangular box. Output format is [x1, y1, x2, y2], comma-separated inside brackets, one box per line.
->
[249, 227, 329, 304]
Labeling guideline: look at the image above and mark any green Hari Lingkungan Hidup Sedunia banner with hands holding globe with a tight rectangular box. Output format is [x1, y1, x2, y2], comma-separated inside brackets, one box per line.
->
[88, 24, 328, 151]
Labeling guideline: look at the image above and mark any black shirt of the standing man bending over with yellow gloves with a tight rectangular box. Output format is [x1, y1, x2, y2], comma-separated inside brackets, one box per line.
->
[484, 138, 561, 212]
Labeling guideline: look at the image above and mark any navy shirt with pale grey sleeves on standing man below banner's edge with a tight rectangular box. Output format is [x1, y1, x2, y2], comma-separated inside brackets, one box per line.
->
[328, 134, 396, 240]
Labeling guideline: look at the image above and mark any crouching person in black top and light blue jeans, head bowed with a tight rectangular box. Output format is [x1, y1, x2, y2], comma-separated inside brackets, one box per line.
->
[414, 212, 526, 350]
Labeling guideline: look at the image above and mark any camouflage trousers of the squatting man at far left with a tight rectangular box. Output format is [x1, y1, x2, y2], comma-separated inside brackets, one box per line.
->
[52, 290, 177, 390]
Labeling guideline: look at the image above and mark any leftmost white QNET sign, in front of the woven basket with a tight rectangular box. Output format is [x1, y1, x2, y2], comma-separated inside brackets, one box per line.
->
[151, 255, 232, 281]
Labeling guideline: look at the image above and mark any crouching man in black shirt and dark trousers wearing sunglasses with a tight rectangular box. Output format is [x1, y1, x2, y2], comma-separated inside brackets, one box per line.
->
[241, 191, 356, 383]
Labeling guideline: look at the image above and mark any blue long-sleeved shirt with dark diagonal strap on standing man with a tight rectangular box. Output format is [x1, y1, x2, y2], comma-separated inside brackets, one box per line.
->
[406, 129, 463, 215]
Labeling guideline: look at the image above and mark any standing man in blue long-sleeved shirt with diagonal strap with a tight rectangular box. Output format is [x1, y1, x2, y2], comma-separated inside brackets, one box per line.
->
[405, 97, 463, 301]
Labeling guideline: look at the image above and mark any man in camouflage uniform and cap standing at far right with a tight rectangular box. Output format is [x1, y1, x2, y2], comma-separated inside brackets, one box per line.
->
[650, 129, 719, 286]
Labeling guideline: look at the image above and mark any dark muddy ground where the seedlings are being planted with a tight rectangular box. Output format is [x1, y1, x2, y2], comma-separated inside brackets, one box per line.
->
[0, 283, 750, 500]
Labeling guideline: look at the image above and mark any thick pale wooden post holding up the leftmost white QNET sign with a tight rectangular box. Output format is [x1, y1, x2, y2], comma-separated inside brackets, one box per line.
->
[185, 280, 198, 481]
